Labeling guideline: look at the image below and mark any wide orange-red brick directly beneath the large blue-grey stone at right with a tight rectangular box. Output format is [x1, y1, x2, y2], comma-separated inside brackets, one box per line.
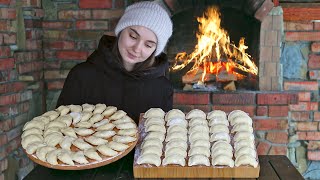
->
[284, 81, 319, 91]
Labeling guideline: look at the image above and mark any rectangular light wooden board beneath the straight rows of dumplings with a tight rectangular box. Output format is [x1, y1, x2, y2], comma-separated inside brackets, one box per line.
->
[133, 115, 260, 178]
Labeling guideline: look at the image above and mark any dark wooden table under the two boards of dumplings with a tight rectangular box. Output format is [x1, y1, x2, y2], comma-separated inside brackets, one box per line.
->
[24, 153, 304, 180]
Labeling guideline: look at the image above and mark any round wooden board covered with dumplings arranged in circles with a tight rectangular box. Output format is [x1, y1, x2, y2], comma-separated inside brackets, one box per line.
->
[21, 104, 138, 170]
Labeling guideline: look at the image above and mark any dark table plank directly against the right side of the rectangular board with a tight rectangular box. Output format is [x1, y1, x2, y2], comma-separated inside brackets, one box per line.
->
[259, 155, 279, 180]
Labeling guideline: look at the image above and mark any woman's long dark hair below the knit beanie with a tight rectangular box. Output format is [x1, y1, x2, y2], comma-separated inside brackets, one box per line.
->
[112, 32, 156, 75]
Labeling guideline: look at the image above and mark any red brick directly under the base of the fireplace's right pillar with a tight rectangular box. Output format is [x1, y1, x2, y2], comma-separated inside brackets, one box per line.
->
[257, 93, 298, 105]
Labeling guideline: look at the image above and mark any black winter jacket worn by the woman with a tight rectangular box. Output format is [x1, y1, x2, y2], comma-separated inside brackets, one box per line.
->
[57, 35, 173, 122]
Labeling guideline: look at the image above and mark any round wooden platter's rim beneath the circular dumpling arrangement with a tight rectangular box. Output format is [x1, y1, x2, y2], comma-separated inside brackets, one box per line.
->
[22, 133, 139, 170]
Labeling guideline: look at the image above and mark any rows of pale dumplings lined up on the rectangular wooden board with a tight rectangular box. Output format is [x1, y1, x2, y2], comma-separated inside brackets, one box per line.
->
[138, 108, 257, 167]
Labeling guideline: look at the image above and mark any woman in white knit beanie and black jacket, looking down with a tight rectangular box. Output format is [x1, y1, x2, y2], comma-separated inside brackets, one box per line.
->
[57, 1, 173, 122]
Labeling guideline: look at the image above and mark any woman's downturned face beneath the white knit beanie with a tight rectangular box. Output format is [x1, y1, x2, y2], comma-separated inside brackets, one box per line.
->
[118, 26, 157, 71]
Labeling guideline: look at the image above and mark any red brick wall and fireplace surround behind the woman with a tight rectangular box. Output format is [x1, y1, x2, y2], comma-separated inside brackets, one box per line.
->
[0, 0, 320, 180]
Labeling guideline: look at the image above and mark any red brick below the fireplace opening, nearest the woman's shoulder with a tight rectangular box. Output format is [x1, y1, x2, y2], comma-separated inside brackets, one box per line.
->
[173, 92, 210, 105]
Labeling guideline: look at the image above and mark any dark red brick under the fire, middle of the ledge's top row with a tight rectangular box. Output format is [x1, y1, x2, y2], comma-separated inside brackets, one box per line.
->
[212, 93, 256, 105]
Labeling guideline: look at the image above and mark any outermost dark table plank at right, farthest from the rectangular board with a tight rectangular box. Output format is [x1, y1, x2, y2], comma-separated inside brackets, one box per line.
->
[269, 155, 304, 180]
